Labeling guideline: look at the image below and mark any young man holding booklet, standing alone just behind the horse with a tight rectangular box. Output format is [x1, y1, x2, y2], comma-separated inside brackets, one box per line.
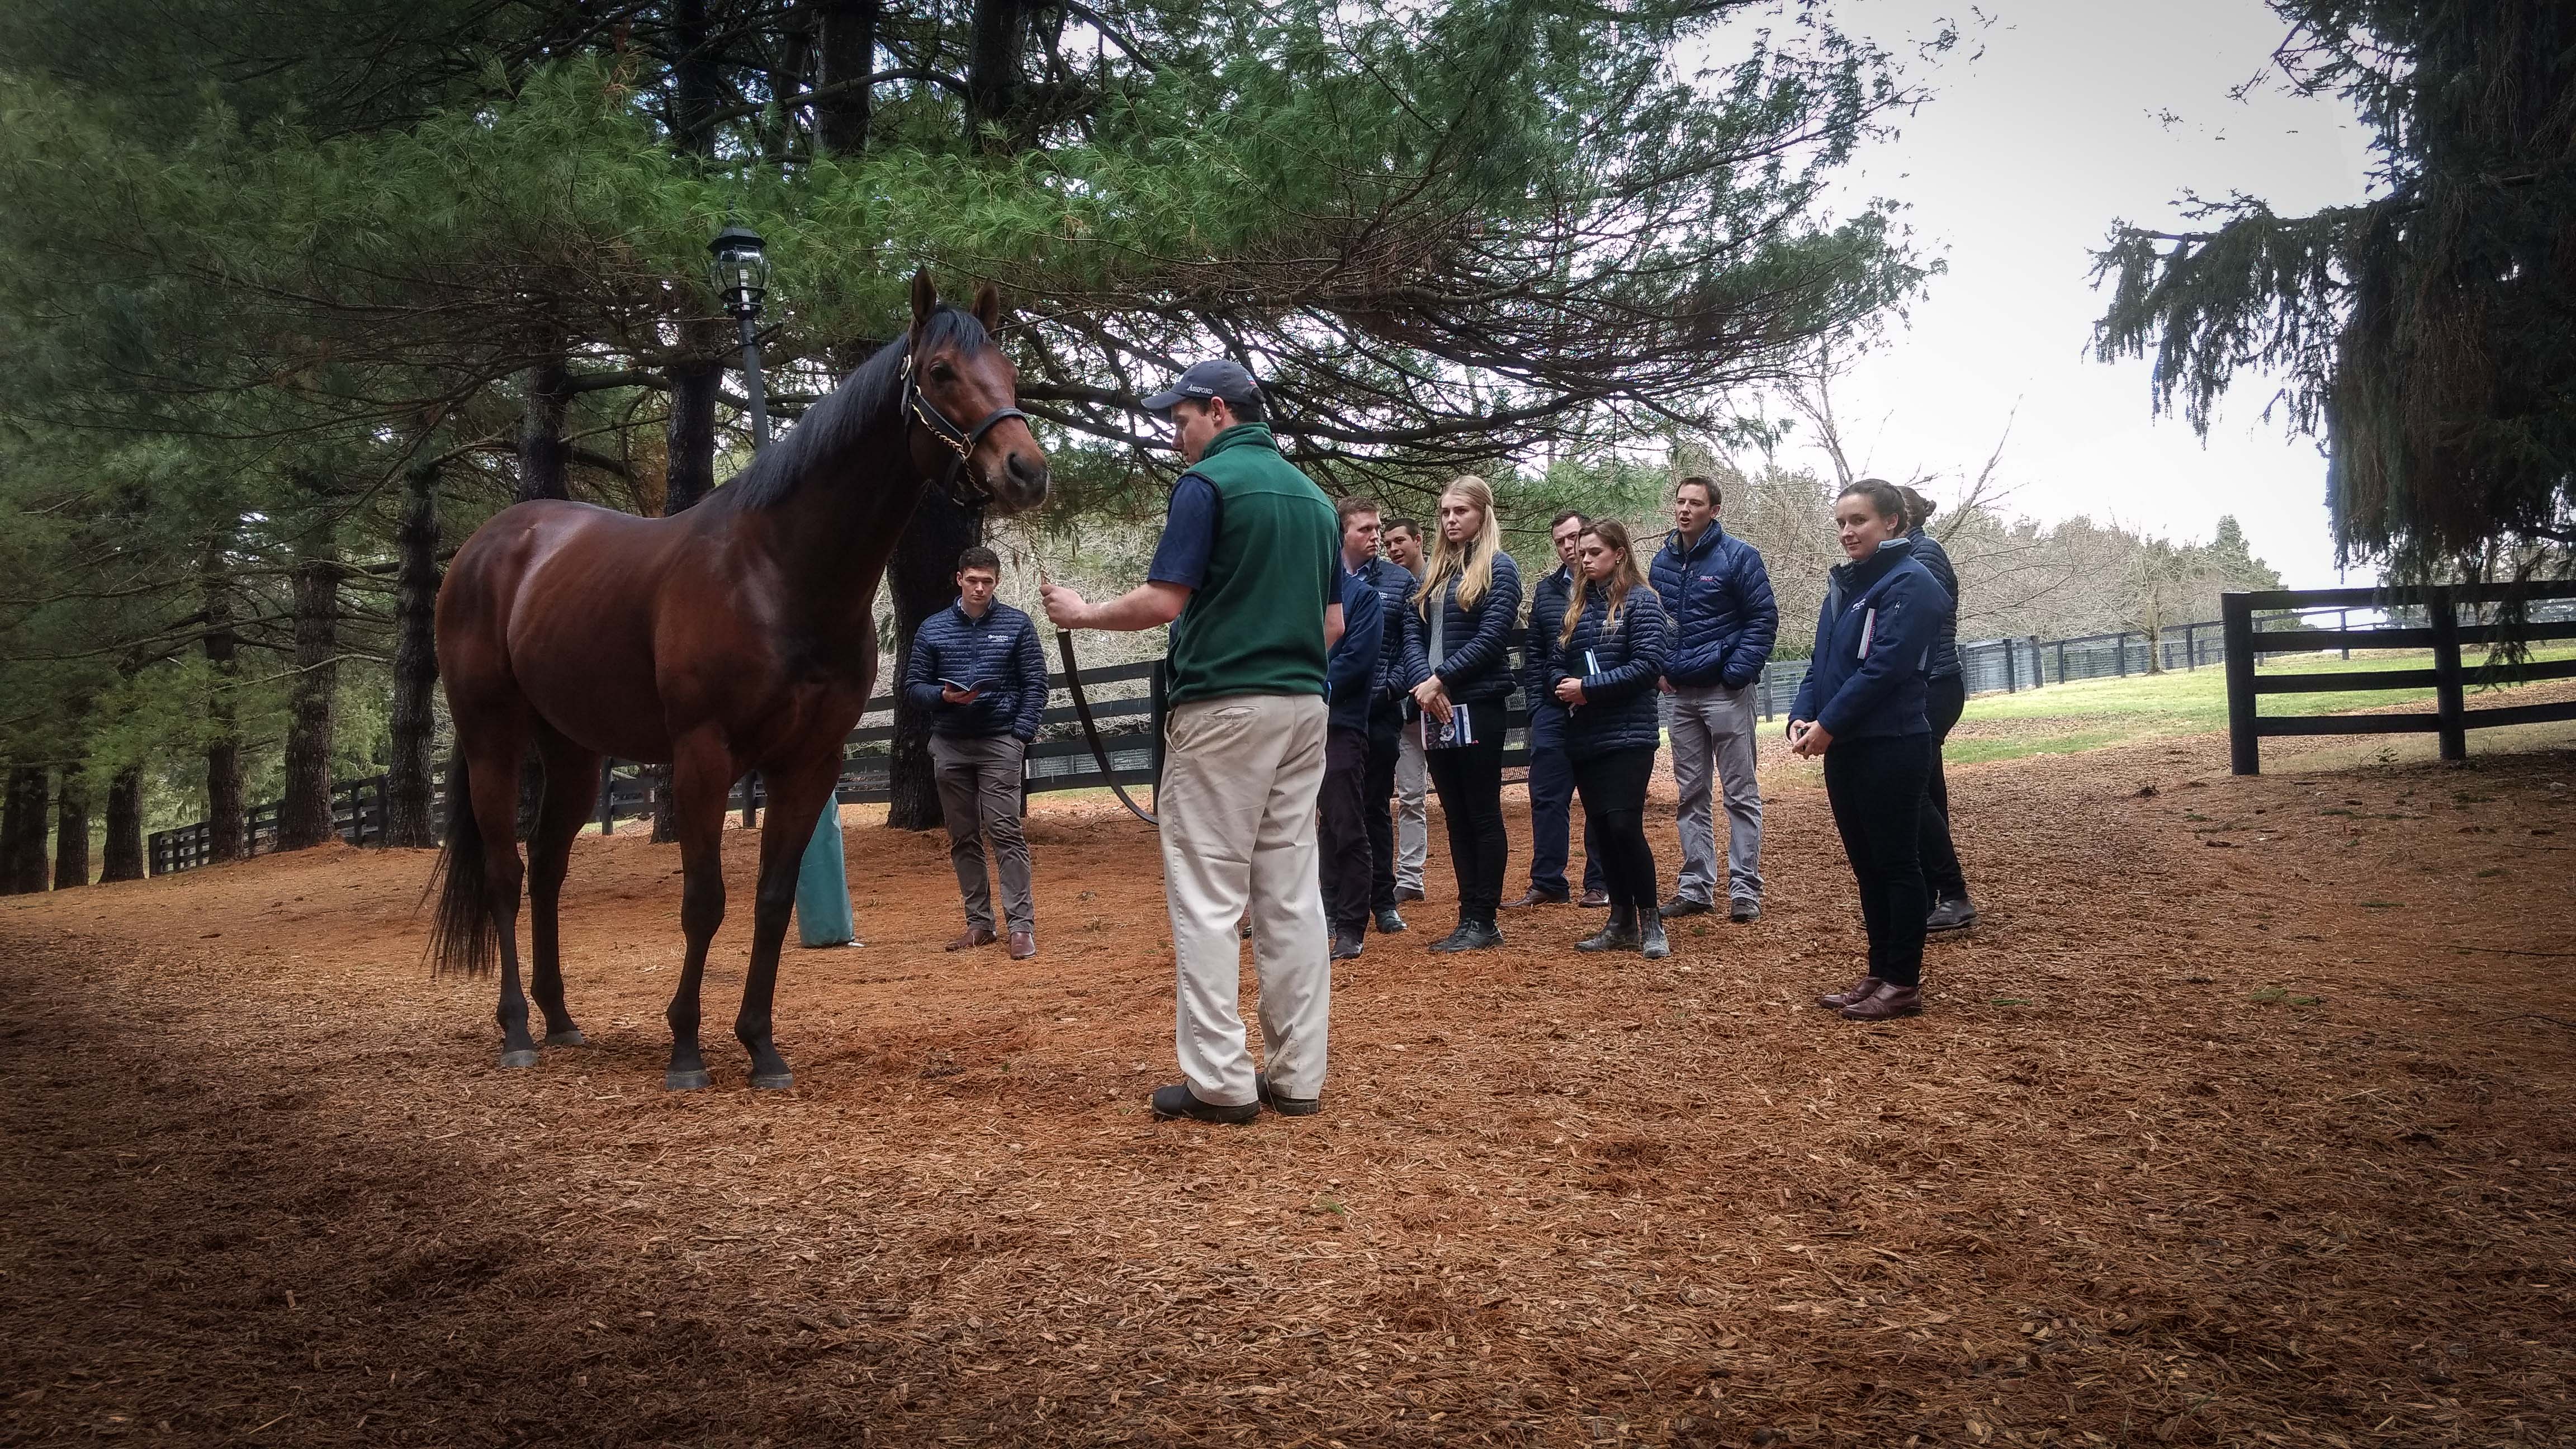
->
[904, 547, 1046, 962]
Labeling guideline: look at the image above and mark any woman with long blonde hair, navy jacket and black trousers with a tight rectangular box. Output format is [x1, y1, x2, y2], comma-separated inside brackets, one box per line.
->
[1404, 477, 1520, 951]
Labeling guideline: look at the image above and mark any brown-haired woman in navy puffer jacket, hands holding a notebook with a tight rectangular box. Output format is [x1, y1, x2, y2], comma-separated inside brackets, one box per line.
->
[1548, 523, 1672, 959]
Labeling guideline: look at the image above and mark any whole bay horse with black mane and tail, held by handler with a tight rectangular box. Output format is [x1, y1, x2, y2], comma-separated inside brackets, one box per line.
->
[430, 271, 1048, 1091]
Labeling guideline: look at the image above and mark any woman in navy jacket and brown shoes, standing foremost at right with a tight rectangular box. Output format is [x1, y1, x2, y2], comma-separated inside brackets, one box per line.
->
[1788, 480, 1950, 1021]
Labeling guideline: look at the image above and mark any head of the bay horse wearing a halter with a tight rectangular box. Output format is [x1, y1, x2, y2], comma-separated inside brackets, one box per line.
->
[904, 268, 1046, 513]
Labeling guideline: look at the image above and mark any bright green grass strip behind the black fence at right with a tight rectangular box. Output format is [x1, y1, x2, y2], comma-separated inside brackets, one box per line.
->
[1945, 645, 2576, 763]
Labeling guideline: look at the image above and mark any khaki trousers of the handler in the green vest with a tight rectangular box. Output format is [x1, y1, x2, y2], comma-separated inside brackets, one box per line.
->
[1154, 694, 1332, 1106]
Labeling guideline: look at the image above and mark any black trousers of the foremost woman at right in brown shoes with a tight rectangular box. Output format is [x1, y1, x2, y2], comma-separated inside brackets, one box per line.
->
[1824, 735, 1932, 985]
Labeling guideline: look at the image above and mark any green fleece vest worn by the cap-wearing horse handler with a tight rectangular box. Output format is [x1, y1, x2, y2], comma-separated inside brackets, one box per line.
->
[1169, 423, 1342, 704]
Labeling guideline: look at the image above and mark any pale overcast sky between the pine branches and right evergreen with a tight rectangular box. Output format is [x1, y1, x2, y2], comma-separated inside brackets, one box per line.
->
[1783, 0, 2375, 588]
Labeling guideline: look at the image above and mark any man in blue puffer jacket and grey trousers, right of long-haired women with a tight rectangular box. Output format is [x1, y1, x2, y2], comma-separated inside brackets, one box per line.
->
[1651, 475, 1780, 921]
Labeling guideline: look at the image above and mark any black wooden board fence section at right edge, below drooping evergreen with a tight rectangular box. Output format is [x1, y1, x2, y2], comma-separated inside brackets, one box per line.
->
[2220, 583, 2576, 776]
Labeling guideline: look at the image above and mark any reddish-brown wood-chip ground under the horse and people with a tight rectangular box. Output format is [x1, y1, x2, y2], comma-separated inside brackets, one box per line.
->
[0, 737, 2576, 1446]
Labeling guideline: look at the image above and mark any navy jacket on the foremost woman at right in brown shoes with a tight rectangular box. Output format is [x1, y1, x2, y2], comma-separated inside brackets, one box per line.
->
[1788, 539, 1950, 750]
